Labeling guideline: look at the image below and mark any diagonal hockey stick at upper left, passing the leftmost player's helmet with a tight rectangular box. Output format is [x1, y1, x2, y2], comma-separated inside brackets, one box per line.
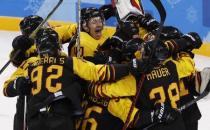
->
[0, 0, 63, 74]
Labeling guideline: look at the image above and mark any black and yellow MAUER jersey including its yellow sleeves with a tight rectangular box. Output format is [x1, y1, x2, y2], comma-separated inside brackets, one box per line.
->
[86, 54, 195, 127]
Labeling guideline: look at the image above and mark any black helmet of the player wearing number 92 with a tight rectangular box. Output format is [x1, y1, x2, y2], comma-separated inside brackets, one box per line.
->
[35, 28, 61, 56]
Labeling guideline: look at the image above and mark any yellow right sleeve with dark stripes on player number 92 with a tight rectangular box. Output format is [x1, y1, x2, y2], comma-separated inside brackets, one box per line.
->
[73, 57, 129, 82]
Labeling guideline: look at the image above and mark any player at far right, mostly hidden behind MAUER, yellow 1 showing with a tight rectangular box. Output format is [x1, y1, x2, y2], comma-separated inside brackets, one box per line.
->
[148, 24, 202, 130]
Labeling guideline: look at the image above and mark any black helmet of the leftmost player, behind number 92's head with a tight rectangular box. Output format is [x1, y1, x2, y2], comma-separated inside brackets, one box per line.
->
[19, 15, 43, 36]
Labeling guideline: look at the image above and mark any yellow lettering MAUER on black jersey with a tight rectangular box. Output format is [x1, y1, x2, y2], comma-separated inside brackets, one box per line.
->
[146, 67, 170, 80]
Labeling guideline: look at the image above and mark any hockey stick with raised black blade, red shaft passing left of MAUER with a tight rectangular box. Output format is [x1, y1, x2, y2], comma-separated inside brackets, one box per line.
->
[122, 0, 166, 130]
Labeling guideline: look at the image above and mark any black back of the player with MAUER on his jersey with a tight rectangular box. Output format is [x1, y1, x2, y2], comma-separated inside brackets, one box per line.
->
[137, 61, 185, 130]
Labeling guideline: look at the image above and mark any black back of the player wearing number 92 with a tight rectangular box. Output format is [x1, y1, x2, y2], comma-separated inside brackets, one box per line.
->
[28, 56, 78, 114]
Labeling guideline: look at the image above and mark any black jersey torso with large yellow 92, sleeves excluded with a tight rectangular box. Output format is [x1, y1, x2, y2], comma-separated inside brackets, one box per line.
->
[24, 56, 77, 110]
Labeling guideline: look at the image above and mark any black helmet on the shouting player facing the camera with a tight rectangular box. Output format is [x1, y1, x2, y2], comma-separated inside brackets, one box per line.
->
[81, 7, 104, 29]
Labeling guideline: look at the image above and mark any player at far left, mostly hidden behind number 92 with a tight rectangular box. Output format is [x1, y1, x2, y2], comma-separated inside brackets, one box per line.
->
[4, 15, 76, 130]
